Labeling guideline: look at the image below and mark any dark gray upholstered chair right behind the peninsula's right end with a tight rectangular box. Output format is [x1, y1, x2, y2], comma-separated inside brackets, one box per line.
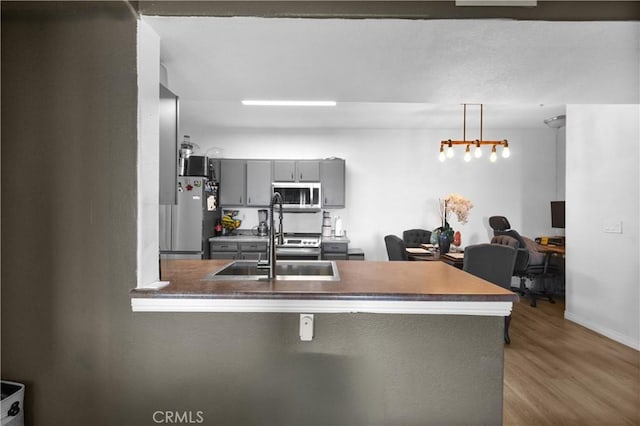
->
[462, 244, 517, 344]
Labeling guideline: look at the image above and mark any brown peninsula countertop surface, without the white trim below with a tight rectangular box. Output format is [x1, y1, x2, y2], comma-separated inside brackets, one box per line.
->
[131, 260, 518, 302]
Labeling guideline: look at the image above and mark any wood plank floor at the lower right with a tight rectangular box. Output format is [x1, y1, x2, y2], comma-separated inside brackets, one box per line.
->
[503, 298, 640, 425]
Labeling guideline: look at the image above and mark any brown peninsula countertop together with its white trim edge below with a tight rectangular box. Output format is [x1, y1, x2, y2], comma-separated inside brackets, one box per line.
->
[131, 260, 518, 316]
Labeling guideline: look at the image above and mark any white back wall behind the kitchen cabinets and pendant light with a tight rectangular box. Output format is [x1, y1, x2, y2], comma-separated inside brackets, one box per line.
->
[181, 113, 556, 260]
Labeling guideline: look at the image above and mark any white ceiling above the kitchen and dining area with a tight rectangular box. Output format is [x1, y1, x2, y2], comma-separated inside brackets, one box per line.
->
[143, 16, 640, 129]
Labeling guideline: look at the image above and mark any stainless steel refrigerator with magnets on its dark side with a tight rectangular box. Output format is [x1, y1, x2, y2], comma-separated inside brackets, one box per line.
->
[160, 176, 217, 259]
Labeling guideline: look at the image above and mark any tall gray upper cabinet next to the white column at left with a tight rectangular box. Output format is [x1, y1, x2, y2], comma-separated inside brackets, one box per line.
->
[158, 85, 178, 204]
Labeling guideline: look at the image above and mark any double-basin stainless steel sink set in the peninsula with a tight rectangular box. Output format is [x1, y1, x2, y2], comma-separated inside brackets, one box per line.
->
[204, 260, 340, 281]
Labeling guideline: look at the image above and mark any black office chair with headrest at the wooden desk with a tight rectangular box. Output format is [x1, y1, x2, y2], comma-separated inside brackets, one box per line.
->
[489, 216, 556, 308]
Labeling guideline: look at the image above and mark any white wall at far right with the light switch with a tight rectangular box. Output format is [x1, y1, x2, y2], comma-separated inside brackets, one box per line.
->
[565, 105, 640, 349]
